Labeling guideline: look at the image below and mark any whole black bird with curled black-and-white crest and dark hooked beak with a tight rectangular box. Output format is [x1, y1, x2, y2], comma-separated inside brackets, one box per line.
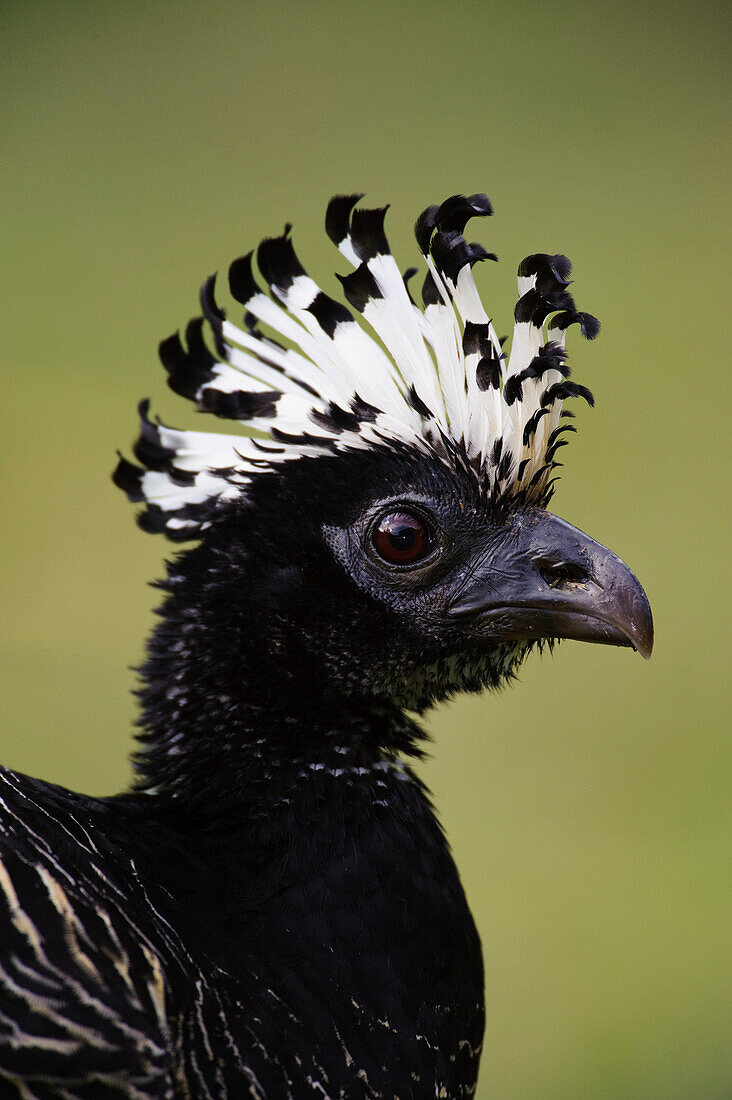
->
[0, 194, 653, 1100]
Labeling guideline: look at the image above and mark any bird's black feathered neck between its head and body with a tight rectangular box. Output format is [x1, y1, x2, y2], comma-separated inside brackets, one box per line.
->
[134, 547, 424, 814]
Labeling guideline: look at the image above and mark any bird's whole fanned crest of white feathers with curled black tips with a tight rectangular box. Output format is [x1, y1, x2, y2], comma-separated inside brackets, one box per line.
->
[114, 195, 599, 539]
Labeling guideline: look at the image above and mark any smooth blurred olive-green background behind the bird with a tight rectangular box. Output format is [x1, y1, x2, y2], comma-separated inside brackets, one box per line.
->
[0, 0, 732, 1100]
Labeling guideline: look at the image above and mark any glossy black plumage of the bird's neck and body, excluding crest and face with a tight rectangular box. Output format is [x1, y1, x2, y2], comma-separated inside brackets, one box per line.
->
[0, 444, 508, 1100]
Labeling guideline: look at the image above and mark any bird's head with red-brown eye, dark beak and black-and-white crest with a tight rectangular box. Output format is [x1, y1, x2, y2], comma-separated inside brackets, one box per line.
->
[114, 195, 653, 730]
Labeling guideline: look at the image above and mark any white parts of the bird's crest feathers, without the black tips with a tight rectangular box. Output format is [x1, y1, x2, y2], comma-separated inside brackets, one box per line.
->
[122, 195, 598, 531]
